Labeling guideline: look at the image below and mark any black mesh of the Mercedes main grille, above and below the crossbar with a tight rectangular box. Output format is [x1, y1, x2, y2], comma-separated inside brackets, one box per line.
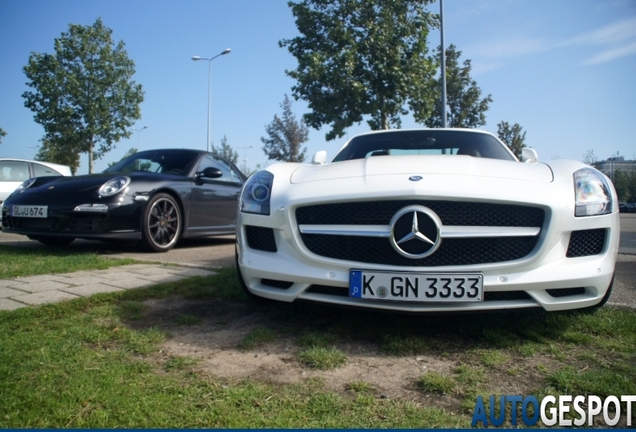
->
[296, 200, 545, 267]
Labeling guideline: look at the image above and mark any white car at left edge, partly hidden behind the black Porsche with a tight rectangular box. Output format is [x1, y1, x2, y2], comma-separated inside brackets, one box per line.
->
[0, 158, 72, 228]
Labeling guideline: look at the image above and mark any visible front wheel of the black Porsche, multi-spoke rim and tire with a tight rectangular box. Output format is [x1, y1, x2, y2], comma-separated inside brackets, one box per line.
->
[141, 193, 183, 252]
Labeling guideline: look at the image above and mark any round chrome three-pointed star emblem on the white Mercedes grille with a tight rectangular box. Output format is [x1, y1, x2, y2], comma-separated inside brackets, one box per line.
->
[390, 205, 442, 259]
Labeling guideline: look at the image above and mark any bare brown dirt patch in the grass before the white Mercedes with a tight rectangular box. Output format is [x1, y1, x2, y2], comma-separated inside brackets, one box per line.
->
[130, 298, 547, 410]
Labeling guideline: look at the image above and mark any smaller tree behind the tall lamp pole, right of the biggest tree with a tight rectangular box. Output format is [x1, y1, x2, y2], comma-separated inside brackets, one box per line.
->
[424, 44, 492, 128]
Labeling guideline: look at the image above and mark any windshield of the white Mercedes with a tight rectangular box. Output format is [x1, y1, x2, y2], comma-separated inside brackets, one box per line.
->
[333, 129, 516, 162]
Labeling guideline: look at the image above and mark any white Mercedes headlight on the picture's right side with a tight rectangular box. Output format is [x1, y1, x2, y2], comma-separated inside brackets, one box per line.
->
[574, 168, 612, 217]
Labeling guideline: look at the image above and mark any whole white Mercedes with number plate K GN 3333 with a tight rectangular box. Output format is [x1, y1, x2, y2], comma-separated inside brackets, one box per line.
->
[236, 129, 620, 313]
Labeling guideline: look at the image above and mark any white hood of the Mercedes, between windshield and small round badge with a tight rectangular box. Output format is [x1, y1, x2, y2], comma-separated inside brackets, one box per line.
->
[290, 155, 553, 184]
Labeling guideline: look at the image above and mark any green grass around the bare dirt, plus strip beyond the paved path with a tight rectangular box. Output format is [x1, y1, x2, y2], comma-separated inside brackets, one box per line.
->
[0, 246, 636, 429]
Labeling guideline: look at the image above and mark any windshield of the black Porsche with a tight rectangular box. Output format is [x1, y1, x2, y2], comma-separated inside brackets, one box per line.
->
[104, 150, 199, 175]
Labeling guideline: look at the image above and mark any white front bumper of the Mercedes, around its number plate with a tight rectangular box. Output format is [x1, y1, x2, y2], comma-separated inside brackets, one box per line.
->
[237, 213, 619, 312]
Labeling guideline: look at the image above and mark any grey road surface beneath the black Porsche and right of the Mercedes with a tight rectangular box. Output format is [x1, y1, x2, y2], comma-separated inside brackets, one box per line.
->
[0, 214, 636, 308]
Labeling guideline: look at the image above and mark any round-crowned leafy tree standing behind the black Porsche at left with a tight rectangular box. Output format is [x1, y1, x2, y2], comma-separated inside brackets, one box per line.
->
[22, 19, 144, 173]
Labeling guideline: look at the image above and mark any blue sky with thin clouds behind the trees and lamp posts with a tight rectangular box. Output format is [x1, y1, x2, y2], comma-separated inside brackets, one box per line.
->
[0, 0, 636, 174]
